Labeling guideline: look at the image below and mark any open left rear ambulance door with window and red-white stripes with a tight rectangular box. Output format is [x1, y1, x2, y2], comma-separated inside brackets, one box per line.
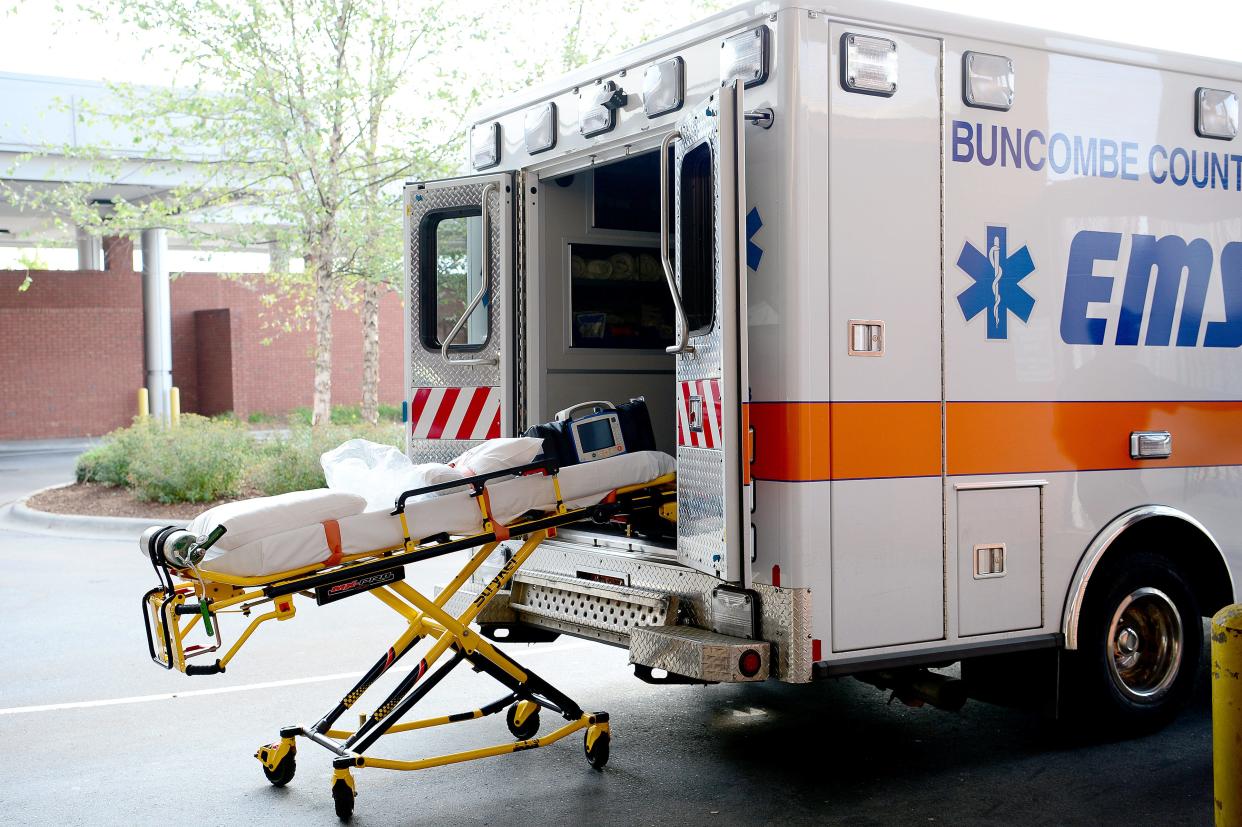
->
[405, 173, 514, 462]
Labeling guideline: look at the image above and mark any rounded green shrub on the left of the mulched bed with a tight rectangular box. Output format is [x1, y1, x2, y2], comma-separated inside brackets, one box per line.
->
[128, 414, 255, 503]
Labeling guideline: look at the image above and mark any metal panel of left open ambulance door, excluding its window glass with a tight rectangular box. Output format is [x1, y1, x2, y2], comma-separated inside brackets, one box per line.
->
[405, 173, 513, 462]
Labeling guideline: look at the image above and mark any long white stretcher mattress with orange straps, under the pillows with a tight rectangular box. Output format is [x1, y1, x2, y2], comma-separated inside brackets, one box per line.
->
[191, 451, 677, 577]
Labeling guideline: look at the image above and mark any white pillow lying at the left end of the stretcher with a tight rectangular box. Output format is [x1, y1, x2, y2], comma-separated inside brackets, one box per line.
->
[186, 488, 366, 551]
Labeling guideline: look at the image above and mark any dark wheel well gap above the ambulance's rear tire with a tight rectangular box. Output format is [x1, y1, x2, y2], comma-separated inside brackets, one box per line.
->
[1087, 515, 1233, 617]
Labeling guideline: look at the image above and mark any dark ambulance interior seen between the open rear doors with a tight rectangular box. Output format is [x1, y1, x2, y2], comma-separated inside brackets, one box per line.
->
[527, 151, 695, 545]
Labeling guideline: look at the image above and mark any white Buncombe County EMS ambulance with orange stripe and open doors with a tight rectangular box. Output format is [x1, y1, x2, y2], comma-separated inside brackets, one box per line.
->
[406, 0, 1242, 719]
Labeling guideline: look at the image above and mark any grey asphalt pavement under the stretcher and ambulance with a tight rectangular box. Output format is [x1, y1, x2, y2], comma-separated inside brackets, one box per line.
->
[0, 454, 1212, 826]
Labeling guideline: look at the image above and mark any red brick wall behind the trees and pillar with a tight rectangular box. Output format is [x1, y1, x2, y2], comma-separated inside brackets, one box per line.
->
[0, 271, 402, 440]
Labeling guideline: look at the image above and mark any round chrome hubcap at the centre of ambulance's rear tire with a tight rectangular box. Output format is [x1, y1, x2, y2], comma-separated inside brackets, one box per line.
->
[1108, 587, 1182, 703]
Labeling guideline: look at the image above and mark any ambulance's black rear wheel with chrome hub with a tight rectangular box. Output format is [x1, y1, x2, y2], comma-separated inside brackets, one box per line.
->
[1062, 551, 1203, 738]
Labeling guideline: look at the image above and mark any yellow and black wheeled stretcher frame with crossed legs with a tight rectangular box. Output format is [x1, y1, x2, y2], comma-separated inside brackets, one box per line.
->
[142, 454, 676, 820]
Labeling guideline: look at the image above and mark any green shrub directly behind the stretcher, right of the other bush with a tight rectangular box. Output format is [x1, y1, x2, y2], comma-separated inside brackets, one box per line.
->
[245, 423, 405, 497]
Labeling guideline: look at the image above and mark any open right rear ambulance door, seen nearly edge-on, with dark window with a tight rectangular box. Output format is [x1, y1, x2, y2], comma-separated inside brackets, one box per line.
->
[662, 83, 753, 581]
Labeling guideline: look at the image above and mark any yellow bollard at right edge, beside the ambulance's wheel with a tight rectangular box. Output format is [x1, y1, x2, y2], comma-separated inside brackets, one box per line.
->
[1212, 603, 1242, 827]
